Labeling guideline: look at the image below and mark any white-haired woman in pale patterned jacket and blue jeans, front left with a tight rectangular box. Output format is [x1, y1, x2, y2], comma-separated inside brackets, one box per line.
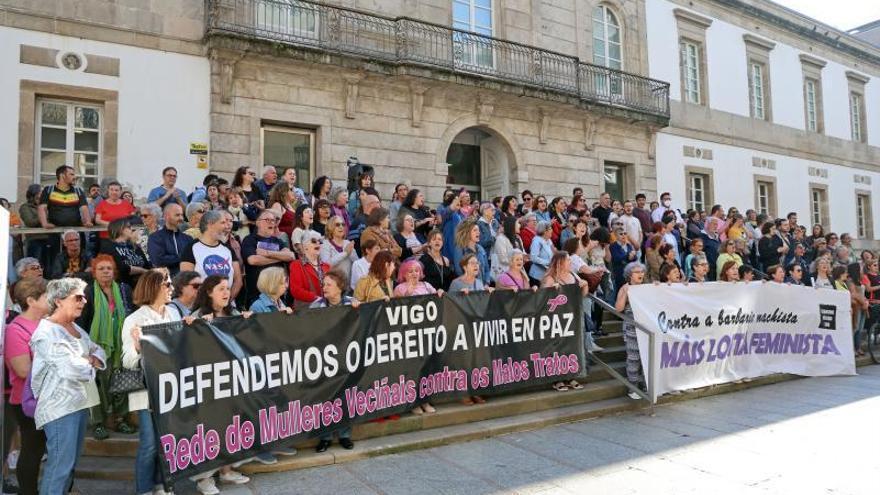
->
[31, 278, 106, 494]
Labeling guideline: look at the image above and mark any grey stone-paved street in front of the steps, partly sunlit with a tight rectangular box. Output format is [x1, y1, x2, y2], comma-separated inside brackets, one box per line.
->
[78, 366, 880, 495]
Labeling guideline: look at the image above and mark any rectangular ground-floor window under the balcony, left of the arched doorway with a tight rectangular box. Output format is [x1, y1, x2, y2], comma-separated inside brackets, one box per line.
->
[262, 126, 315, 190]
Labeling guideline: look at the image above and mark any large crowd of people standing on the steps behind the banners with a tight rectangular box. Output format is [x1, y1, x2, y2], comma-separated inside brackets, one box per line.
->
[4, 166, 880, 494]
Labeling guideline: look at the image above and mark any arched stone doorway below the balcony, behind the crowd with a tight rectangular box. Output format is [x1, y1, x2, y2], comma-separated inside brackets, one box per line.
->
[446, 127, 515, 201]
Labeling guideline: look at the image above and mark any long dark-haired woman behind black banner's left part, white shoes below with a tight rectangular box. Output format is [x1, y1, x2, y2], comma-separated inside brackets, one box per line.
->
[191, 275, 253, 495]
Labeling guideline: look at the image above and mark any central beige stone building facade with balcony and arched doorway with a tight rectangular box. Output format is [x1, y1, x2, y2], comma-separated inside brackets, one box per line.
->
[206, 0, 667, 201]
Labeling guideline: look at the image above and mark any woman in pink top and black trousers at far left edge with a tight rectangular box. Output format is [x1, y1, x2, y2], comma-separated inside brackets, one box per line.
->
[3, 278, 49, 495]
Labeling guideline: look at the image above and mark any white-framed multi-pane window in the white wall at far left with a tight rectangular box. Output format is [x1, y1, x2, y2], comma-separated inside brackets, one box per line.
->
[34, 100, 103, 187]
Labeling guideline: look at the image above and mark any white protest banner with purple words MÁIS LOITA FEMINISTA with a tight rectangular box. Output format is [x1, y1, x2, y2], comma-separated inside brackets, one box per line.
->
[629, 282, 856, 399]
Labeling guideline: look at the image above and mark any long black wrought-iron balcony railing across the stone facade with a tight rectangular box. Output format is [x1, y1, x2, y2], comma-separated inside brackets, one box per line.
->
[208, 0, 669, 118]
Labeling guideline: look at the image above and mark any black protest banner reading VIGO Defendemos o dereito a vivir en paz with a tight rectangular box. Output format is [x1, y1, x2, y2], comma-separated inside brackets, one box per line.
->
[141, 286, 585, 481]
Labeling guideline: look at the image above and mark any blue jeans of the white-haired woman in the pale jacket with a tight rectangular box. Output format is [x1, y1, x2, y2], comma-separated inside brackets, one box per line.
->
[40, 409, 89, 495]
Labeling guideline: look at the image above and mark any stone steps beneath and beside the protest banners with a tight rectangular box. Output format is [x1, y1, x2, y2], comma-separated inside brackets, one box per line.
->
[67, 320, 869, 480]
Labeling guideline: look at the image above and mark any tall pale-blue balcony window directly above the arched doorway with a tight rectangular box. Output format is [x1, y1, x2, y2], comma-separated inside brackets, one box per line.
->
[452, 0, 495, 68]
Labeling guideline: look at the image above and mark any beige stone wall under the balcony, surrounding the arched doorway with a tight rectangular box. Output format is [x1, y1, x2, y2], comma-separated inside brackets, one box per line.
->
[210, 49, 656, 202]
